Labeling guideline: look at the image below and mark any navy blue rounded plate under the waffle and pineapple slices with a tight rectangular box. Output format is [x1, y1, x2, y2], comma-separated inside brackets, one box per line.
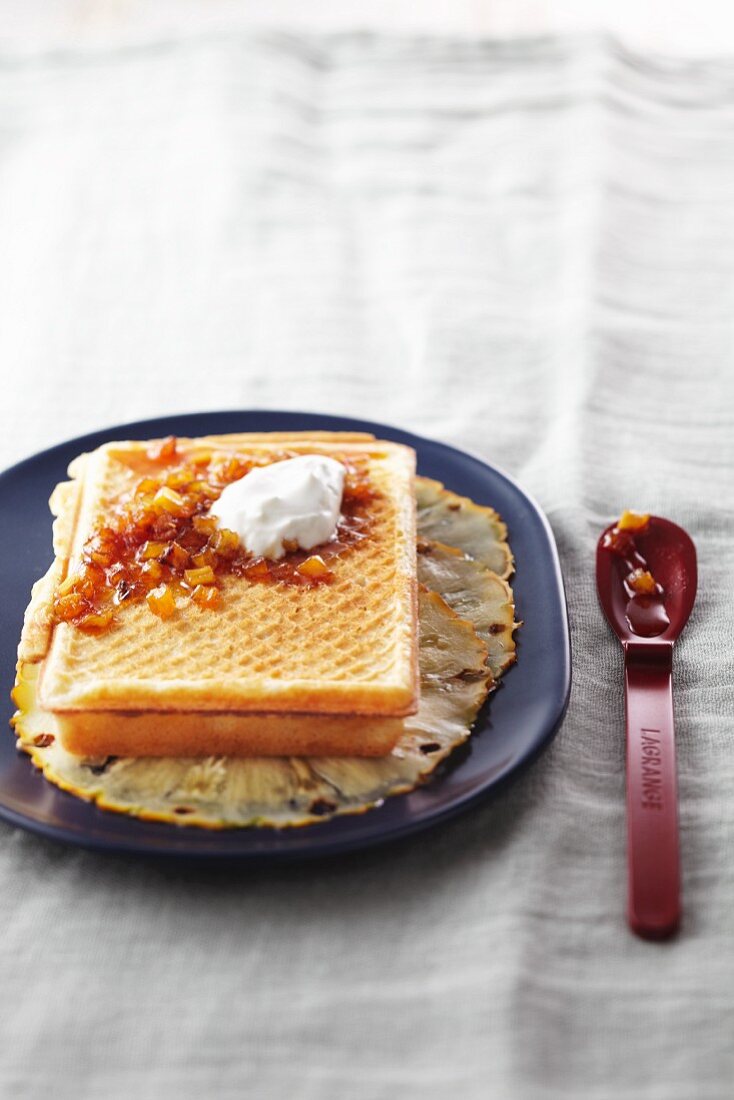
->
[0, 411, 571, 860]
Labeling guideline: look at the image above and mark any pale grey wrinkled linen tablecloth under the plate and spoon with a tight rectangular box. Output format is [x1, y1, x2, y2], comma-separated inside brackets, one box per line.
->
[0, 35, 734, 1100]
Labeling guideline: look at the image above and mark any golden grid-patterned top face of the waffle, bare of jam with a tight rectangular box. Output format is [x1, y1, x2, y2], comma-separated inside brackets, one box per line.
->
[43, 444, 413, 695]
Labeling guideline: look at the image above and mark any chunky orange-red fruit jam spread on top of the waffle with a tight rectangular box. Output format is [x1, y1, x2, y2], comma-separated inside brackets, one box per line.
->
[54, 437, 374, 633]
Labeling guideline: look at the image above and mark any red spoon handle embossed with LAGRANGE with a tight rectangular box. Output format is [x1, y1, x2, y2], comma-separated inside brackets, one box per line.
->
[625, 641, 680, 939]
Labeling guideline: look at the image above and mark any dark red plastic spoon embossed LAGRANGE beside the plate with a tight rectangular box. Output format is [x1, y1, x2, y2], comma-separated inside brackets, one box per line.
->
[596, 516, 698, 939]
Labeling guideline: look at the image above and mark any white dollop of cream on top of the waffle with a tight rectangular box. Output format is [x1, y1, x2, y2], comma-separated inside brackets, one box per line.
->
[210, 454, 346, 559]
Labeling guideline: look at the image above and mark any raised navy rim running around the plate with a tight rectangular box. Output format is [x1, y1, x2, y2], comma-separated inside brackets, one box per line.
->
[0, 408, 572, 864]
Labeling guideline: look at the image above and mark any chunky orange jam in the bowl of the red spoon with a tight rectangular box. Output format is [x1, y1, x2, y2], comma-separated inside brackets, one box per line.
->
[603, 512, 670, 638]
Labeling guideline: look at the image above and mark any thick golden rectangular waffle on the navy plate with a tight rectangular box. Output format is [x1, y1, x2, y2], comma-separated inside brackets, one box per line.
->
[20, 433, 418, 756]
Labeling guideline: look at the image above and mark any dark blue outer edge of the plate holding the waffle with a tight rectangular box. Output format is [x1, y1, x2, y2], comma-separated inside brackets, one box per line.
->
[0, 409, 572, 866]
